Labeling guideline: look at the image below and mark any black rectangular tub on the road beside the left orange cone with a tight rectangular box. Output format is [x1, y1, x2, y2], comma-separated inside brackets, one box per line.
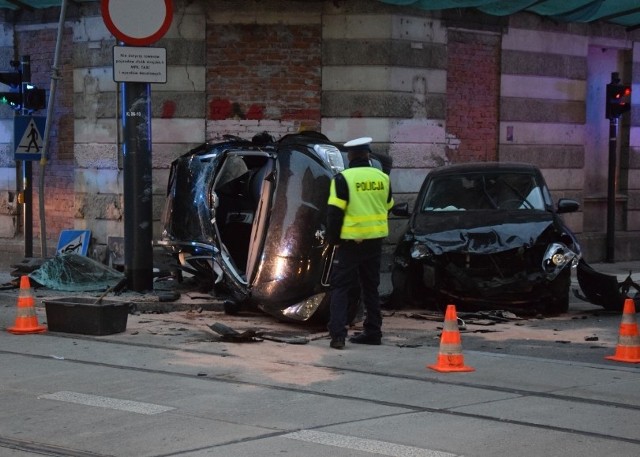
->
[44, 297, 129, 335]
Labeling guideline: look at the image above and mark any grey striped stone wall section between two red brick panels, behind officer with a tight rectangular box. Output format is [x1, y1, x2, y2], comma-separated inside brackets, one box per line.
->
[322, 1, 448, 244]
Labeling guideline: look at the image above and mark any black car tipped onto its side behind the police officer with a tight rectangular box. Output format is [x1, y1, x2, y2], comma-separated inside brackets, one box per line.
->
[156, 132, 389, 322]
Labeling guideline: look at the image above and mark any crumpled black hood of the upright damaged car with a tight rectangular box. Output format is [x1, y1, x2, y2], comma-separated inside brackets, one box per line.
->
[413, 210, 553, 255]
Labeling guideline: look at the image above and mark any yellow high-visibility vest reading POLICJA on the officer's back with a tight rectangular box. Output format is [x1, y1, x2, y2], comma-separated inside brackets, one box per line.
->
[328, 167, 393, 240]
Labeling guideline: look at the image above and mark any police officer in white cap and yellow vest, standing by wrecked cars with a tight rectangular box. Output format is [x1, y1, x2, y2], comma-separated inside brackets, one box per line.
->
[327, 137, 393, 349]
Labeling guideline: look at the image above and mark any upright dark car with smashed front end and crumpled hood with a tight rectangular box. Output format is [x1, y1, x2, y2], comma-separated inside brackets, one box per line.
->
[390, 162, 581, 314]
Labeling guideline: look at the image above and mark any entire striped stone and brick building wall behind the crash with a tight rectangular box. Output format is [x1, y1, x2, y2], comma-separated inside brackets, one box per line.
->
[0, 0, 640, 258]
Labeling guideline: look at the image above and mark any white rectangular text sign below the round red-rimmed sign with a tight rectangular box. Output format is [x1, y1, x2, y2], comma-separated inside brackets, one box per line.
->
[113, 46, 167, 83]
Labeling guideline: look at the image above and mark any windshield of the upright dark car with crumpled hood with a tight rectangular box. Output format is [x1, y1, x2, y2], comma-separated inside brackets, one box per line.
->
[421, 172, 545, 211]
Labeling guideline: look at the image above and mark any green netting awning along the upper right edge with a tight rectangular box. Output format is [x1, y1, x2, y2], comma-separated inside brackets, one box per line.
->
[378, 0, 640, 30]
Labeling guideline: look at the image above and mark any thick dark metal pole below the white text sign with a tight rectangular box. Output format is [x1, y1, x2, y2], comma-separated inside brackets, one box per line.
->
[122, 82, 153, 292]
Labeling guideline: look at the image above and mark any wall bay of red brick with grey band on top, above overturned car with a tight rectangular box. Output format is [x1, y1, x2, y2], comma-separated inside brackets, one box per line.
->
[205, 1, 322, 139]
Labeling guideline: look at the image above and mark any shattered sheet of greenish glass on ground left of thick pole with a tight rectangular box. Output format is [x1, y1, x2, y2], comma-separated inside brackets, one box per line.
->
[29, 253, 125, 292]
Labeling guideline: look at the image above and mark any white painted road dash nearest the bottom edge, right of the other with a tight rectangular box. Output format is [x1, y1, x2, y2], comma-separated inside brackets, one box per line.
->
[282, 430, 456, 457]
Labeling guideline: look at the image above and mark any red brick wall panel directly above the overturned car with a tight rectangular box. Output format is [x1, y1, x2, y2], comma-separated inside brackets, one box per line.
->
[206, 23, 321, 136]
